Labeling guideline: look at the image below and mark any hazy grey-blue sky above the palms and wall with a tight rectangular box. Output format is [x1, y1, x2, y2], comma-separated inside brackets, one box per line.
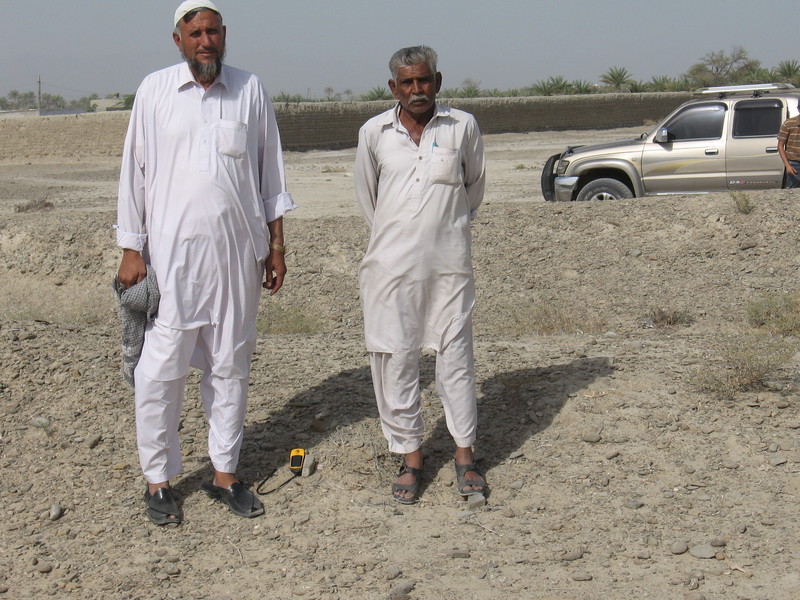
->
[0, 0, 800, 99]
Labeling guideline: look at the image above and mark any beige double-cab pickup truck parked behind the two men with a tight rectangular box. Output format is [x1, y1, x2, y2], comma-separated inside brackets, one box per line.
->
[541, 83, 800, 201]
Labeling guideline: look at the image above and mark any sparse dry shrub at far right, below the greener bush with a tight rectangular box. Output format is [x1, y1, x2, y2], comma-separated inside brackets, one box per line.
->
[694, 336, 794, 400]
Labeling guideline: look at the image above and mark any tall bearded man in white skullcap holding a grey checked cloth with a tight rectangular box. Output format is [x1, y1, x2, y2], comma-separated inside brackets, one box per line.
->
[115, 0, 296, 525]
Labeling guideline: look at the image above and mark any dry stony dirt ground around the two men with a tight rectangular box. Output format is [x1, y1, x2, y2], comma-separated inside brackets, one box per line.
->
[0, 128, 800, 600]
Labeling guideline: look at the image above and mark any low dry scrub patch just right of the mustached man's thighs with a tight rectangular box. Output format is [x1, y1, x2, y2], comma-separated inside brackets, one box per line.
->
[501, 302, 605, 335]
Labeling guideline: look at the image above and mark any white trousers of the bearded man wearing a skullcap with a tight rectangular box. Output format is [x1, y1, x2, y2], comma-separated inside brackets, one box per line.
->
[134, 321, 249, 483]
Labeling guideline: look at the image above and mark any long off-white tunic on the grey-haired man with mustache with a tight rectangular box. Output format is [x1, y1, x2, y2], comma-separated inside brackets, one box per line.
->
[355, 104, 485, 353]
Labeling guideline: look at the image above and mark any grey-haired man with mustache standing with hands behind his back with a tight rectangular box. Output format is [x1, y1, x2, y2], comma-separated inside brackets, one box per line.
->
[355, 46, 486, 504]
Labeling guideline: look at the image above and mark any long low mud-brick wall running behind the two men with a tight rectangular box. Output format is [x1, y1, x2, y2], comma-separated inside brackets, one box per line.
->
[0, 93, 691, 161]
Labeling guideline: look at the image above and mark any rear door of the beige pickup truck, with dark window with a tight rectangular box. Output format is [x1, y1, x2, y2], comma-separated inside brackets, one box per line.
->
[725, 98, 786, 190]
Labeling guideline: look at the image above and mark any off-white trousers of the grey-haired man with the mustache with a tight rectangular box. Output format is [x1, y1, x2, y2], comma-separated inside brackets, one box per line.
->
[369, 321, 478, 454]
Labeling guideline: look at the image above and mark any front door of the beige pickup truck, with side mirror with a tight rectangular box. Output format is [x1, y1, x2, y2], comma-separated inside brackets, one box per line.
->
[642, 102, 728, 194]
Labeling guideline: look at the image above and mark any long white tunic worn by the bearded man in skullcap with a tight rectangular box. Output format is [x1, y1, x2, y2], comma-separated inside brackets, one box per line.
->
[116, 63, 295, 376]
